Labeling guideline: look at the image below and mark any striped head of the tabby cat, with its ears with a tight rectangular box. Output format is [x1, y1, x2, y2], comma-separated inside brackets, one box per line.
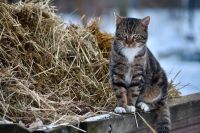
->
[115, 15, 150, 48]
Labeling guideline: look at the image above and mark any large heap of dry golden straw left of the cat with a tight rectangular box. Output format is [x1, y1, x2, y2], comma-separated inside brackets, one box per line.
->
[0, 2, 180, 127]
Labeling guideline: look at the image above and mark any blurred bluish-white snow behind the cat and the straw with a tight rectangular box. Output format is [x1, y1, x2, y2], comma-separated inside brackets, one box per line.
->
[60, 9, 200, 95]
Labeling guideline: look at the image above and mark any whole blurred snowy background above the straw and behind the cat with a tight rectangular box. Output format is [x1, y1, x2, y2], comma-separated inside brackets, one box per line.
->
[7, 0, 200, 95]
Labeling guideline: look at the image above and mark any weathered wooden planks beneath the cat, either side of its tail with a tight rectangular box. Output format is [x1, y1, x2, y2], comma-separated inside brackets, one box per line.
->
[81, 93, 200, 133]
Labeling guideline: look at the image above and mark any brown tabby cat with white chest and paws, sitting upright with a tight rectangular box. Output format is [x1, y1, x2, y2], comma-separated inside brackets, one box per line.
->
[109, 15, 171, 133]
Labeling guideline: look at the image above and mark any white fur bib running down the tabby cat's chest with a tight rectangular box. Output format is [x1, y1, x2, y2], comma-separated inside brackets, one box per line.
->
[122, 48, 142, 86]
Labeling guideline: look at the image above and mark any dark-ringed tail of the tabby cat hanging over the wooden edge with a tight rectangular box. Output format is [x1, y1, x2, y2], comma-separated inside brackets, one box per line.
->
[156, 103, 171, 133]
